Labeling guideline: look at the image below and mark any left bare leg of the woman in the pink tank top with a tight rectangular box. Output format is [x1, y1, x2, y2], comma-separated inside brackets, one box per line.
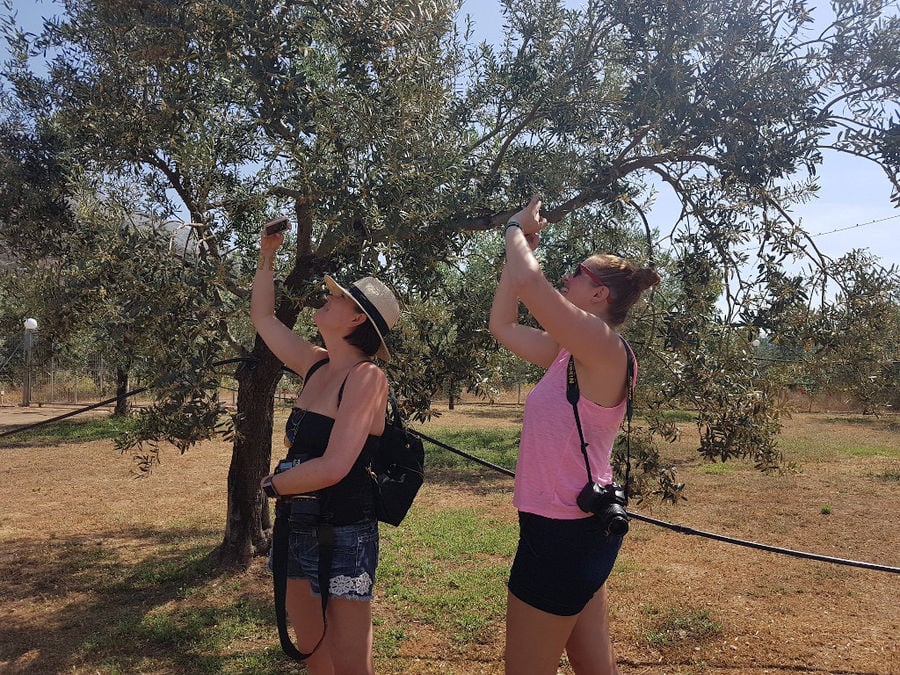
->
[505, 591, 578, 675]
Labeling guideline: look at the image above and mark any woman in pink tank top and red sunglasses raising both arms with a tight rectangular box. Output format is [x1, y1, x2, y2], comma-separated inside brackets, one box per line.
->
[490, 198, 659, 675]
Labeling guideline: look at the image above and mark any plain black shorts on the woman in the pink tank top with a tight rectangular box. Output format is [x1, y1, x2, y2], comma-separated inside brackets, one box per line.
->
[508, 512, 622, 616]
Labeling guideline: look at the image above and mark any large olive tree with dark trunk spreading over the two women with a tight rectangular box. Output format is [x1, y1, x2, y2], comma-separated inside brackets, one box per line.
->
[4, 0, 900, 565]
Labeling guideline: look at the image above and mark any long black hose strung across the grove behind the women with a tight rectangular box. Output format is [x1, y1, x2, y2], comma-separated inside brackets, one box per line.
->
[0, 370, 900, 574]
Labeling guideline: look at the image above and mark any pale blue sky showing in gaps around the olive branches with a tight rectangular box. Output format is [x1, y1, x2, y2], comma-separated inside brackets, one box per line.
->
[12, 0, 900, 266]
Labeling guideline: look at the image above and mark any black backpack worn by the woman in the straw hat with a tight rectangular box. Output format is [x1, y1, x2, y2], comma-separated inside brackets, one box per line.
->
[371, 395, 425, 525]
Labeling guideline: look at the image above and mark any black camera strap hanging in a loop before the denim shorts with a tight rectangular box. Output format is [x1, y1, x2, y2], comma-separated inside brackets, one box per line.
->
[272, 513, 334, 661]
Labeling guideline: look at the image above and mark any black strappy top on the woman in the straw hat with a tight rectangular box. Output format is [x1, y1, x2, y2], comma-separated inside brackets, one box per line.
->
[285, 361, 381, 525]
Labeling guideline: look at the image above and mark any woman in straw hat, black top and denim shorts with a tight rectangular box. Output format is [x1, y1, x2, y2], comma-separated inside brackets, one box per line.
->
[250, 223, 400, 675]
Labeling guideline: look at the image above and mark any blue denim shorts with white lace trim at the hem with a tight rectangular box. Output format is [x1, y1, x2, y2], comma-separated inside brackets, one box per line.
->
[287, 520, 378, 600]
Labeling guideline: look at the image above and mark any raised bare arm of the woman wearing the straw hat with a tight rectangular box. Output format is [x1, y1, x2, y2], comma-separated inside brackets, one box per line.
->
[250, 226, 326, 375]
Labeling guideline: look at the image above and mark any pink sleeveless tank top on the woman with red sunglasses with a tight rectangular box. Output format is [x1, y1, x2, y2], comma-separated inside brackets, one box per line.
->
[513, 349, 637, 520]
